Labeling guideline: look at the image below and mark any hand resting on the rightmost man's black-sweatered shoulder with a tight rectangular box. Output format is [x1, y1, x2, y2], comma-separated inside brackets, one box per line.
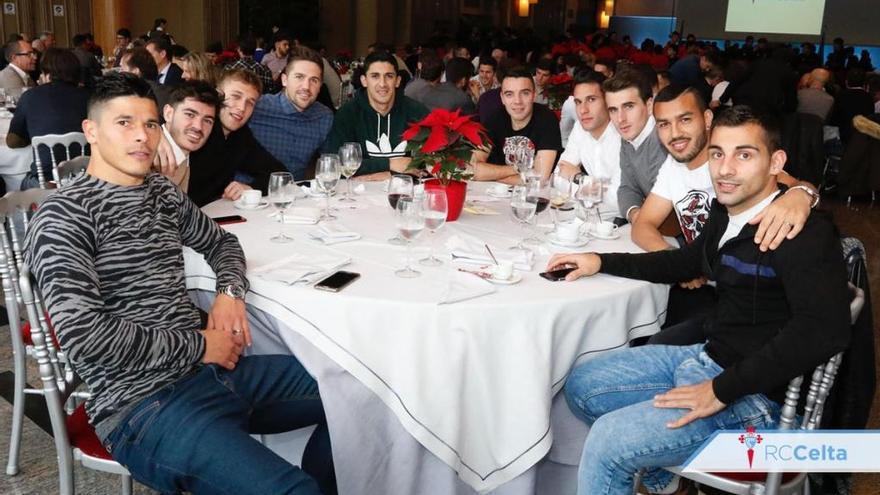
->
[749, 190, 813, 251]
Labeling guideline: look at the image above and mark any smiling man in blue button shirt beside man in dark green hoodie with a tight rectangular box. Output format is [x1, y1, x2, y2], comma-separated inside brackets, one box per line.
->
[248, 47, 337, 180]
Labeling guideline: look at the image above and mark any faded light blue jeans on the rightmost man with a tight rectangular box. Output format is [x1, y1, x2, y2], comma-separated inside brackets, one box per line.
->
[565, 344, 780, 495]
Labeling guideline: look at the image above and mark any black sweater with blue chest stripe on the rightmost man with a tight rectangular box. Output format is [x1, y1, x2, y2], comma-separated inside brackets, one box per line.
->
[600, 193, 850, 404]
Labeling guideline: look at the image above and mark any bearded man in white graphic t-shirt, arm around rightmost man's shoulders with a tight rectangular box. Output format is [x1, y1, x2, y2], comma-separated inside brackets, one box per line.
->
[632, 84, 818, 338]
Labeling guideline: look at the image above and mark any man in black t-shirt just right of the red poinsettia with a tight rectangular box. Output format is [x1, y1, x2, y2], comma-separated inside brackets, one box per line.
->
[472, 68, 562, 184]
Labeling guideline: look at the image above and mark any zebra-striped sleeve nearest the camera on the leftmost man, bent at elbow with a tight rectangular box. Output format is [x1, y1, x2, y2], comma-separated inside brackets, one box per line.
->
[25, 198, 205, 370]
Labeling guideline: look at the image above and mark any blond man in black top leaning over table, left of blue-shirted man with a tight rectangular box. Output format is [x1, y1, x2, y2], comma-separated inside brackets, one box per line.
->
[187, 69, 286, 206]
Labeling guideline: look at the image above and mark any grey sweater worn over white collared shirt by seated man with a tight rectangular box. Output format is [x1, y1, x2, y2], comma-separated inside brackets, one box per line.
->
[617, 130, 666, 218]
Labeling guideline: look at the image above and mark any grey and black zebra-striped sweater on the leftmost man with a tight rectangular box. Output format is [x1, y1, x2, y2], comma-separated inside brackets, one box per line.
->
[25, 174, 247, 433]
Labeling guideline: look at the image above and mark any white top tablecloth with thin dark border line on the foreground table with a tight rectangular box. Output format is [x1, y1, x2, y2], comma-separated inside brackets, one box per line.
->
[185, 184, 667, 493]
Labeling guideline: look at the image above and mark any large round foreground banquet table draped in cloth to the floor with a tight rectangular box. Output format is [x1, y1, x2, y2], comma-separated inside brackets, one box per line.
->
[184, 183, 668, 495]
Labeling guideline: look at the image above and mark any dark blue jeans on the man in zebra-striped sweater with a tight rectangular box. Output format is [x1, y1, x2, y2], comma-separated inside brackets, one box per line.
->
[105, 356, 335, 495]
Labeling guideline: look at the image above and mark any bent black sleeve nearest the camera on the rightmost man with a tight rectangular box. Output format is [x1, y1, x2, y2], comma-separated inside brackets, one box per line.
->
[716, 217, 851, 404]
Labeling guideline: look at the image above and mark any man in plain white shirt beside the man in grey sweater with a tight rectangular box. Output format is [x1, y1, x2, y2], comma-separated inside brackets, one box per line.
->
[558, 70, 620, 220]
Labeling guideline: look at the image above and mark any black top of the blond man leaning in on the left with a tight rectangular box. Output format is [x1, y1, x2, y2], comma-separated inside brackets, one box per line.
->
[187, 119, 287, 207]
